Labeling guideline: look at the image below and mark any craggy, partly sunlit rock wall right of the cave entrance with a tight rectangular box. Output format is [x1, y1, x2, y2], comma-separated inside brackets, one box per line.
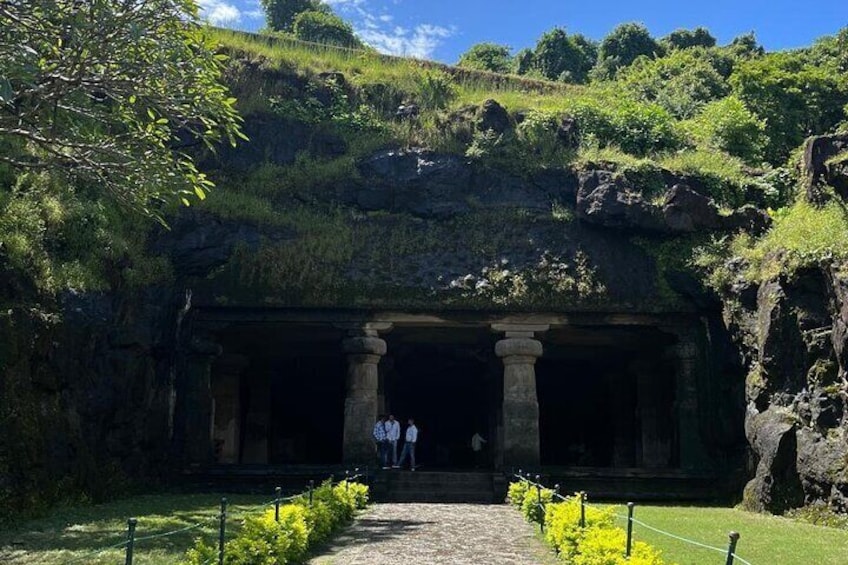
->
[724, 136, 848, 512]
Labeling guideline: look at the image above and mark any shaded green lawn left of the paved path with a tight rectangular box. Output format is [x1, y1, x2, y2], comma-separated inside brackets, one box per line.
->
[0, 494, 273, 565]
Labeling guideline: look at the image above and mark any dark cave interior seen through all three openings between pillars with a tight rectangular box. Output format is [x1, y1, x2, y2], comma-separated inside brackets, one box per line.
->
[212, 323, 679, 469]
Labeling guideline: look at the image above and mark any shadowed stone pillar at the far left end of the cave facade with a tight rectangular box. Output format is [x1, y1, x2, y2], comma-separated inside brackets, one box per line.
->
[179, 335, 223, 465]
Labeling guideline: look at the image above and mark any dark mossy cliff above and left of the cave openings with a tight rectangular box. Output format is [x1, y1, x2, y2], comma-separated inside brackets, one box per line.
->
[0, 112, 744, 508]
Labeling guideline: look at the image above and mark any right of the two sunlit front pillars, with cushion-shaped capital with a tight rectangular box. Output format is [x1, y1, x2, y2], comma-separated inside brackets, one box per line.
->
[492, 324, 548, 468]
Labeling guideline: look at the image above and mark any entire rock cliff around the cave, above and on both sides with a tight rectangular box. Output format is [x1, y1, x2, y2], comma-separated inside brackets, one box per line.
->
[0, 50, 848, 511]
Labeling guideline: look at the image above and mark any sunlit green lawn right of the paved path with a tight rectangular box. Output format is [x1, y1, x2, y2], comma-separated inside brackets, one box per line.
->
[604, 505, 848, 565]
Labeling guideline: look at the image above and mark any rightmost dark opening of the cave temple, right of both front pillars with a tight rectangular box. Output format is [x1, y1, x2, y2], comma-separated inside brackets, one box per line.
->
[536, 328, 680, 469]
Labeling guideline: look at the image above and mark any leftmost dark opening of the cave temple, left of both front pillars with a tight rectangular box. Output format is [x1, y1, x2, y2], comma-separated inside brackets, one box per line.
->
[212, 325, 346, 465]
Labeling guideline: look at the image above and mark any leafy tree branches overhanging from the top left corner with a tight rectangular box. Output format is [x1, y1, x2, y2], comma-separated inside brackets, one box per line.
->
[0, 0, 242, 215]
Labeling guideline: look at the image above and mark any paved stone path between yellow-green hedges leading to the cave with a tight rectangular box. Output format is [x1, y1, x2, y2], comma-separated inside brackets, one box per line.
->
[309, 504, 556, 565]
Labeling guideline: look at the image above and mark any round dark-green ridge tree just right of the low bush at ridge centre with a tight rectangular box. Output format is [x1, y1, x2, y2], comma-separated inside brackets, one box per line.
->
[533, 28, 596, 83]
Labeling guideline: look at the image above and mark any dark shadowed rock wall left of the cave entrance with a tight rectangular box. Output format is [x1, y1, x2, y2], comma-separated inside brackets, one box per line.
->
[0, 289, 178, 516]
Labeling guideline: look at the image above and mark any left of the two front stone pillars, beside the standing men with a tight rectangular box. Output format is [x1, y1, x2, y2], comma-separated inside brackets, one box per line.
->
[342, 323, 391, 465]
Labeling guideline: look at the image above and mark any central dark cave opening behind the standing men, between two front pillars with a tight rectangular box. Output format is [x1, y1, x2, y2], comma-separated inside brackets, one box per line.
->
[382, 328, 502, 469]
